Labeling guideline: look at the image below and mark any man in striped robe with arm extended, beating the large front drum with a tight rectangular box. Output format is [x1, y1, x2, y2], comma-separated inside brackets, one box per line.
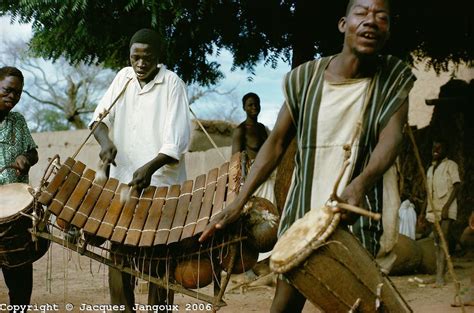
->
[200, 0, 415, 312]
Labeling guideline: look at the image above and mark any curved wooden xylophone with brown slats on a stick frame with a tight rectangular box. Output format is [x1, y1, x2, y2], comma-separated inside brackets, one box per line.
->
[33, 153, 252, 307]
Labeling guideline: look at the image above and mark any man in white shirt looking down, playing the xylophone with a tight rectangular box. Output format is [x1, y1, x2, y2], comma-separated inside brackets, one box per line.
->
[91, 29, 190, 312]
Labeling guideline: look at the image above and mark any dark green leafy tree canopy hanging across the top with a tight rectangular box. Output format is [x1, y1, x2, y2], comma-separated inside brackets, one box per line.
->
[0, 0, 473, 85]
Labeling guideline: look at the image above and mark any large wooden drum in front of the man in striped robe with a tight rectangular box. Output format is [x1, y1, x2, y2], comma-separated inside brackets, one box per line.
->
[270, 207, 411, 313]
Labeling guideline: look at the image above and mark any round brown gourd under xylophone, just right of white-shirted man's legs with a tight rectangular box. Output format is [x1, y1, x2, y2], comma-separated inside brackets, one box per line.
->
[174, 258, 213, 289]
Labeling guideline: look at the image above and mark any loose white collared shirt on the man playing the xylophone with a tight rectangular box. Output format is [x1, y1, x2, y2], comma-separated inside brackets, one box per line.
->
[90, 65, 191, 186]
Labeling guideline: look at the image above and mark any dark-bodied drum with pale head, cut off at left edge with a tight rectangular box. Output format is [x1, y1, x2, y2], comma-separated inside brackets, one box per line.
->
[0, 183, 49, 267]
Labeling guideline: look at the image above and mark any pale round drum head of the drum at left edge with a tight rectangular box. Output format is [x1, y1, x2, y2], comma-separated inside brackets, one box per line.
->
[0, 183, 33, 222]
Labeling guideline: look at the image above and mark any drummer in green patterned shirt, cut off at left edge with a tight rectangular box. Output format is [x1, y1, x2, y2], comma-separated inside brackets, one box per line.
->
[0, 66, 38, 305]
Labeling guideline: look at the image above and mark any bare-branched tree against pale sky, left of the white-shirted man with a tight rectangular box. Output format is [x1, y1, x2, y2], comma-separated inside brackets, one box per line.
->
[0, 41, 113, 131]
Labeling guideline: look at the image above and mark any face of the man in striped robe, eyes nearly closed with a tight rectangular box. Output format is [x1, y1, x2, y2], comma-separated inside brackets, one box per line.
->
[339, 0, 390, 56]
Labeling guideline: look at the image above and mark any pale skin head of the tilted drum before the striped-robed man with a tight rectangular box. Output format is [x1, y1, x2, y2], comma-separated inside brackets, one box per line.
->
[270, 206, 334, 273]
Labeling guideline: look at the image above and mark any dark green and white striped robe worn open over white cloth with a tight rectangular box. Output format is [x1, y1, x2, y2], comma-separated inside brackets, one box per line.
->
[279, 56, 416, 255]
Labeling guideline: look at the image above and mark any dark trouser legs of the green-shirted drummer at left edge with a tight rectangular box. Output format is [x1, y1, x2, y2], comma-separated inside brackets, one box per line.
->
[2, 263, 33, 304]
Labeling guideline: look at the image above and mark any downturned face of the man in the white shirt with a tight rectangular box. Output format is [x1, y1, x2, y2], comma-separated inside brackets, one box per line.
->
[130, 43, 158, 83]
